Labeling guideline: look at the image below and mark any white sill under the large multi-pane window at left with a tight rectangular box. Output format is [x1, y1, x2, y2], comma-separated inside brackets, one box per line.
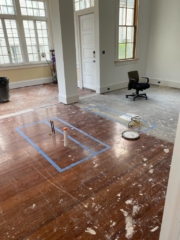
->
[0, 62, 48, 71]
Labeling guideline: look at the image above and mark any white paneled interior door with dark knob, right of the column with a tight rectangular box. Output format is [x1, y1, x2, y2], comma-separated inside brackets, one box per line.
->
[80, 13, 96, 90]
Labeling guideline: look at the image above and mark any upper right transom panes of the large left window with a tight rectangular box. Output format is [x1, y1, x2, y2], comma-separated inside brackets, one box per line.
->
[20, 0, 46, 17]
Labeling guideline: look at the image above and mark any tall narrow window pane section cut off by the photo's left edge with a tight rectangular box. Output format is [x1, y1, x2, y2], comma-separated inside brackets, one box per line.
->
[0, 19, 10, 65]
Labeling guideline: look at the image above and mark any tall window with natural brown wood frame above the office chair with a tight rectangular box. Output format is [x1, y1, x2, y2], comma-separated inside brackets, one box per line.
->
[118, 0, 138, 60]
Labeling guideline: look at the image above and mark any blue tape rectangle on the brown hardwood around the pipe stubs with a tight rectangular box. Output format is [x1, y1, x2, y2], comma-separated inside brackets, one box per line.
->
[16, 117, 110, 173]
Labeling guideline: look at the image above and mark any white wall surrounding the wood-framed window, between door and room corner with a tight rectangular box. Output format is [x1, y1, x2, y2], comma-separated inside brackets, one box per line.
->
[99, 0, 151, 93]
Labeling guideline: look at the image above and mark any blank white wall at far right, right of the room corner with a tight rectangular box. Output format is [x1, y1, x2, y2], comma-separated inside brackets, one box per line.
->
[147, 0, 180, 87]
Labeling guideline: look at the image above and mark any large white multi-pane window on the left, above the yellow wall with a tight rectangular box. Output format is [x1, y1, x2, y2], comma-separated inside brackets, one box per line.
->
[0, 0, 50, 66]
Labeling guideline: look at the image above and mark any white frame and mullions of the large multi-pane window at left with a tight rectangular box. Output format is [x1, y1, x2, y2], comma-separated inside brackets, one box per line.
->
[0, 0, 53, 70]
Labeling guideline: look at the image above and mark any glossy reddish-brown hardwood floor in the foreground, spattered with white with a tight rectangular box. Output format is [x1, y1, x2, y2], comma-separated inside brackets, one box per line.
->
[0, 104, 173, 240]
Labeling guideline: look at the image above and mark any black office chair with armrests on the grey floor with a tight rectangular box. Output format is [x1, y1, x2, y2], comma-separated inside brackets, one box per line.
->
[126, 71, 150, 101]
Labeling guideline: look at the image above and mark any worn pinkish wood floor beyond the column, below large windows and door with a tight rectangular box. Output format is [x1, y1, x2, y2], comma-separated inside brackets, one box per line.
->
[0, 83, 94, 117]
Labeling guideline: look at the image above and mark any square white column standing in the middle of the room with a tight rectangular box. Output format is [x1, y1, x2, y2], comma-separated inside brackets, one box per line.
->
[49, 0, 79, 104]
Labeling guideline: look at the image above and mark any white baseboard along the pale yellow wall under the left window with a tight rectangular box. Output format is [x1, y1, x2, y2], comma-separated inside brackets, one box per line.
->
[9, 77, 53, 89]
